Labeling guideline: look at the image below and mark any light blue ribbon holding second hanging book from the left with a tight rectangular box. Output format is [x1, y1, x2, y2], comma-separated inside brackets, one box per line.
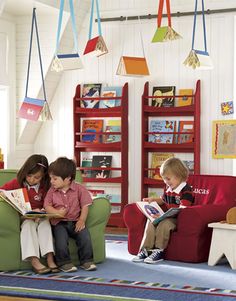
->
[55, 0, 79, 55]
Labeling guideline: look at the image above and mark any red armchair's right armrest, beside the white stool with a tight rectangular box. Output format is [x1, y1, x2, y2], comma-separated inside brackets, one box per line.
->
[177, 204, 229, 235]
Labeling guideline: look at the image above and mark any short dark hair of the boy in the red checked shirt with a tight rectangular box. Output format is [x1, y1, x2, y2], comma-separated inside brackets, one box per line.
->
[48, 157, 76, 181]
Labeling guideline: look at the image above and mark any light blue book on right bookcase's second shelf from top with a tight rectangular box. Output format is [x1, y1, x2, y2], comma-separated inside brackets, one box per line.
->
[148, 119, 176, 143]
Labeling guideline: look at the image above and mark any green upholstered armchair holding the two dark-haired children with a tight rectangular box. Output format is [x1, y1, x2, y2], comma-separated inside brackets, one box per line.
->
[0, 169, 111, 271]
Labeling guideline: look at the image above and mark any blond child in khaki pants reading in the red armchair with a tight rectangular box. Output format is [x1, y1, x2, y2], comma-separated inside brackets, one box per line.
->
[133, 158, 194, 263]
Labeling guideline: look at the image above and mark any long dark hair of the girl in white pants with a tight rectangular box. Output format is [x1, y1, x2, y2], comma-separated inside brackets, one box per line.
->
[17, 154, 50, 189]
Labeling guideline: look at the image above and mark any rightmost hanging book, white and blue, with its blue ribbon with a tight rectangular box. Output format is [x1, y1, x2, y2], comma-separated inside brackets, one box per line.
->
[184, 0, 213, 70]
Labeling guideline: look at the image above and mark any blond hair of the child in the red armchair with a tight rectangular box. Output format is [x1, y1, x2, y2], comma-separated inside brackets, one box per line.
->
[160, 158, 189, 181]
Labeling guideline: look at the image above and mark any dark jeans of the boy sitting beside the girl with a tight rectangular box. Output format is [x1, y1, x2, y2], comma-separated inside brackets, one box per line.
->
[52, 221, 93, 266]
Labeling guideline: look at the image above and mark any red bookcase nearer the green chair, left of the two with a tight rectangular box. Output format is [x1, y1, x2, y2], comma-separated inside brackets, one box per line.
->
[73, 83, 128, 228]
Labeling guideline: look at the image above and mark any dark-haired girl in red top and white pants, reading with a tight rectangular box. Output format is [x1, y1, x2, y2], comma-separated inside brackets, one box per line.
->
[0, 154, 59, 274]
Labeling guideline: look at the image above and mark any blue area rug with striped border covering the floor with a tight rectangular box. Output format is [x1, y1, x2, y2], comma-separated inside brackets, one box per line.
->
[0, 235, 236, 301]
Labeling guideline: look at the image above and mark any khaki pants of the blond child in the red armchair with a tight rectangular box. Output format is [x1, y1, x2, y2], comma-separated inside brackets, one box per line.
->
[141, 218, 177, 250]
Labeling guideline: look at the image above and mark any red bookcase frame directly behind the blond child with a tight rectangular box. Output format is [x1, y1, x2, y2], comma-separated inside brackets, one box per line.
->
[141, 80, 201, 198]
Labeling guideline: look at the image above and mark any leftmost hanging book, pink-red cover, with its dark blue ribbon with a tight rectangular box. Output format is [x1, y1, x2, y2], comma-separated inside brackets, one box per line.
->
[18, 8, 52, 121]
